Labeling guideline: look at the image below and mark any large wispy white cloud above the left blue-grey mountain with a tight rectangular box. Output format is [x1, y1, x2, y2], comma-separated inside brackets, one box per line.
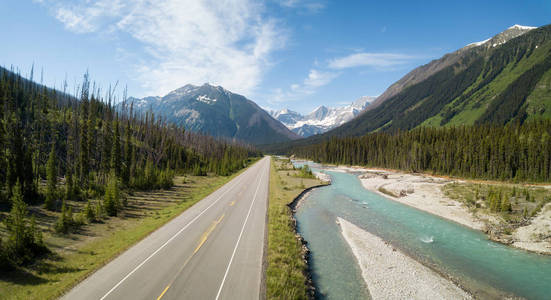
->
[43, 0, 286, 95]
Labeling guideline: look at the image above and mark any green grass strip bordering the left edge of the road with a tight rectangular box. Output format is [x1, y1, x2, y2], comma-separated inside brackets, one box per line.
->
[0, 166, 252, 299]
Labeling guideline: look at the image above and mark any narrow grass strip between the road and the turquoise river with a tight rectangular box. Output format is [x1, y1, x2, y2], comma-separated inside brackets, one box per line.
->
[266, 157, 328, 299]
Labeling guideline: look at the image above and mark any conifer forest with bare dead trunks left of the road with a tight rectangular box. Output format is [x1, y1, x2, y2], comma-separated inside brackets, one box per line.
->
[0, 68, 260, 264]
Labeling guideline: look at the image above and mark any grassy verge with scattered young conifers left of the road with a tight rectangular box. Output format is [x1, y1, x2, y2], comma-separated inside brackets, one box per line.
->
[0, 166, 253, 299]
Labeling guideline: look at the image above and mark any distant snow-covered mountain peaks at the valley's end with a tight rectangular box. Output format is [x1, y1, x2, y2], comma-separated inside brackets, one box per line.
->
[270, 96, 375, 137]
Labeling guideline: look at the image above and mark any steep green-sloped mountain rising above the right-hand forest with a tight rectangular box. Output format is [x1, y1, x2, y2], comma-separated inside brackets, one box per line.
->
[326, 25, 551, 136]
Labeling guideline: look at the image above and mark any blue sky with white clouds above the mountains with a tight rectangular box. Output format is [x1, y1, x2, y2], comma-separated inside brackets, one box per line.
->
[0, 0, 551, 113]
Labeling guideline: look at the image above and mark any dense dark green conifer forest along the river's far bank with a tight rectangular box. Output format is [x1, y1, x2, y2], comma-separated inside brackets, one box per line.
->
[291, 120, 551, 182]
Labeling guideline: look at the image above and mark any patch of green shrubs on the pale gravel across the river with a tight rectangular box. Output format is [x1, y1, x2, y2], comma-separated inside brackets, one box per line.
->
[442, 183, 551, 235]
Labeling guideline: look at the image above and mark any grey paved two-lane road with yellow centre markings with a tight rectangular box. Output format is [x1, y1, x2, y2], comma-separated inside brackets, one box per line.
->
[63, 157, 270, 300]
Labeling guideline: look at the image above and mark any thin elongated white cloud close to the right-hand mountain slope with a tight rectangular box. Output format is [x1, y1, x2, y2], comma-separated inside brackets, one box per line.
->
[329, 52, 416, 69]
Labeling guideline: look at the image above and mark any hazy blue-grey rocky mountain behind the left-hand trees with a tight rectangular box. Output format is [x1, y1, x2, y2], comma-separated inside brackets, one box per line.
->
[128, 83, 300, 144]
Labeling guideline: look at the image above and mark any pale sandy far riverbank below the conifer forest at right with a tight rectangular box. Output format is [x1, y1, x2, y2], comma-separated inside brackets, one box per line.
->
[334, 166, 551, 255]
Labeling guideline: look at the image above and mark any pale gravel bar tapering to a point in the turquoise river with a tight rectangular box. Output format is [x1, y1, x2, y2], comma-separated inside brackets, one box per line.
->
[337, 218, 472, 299]
